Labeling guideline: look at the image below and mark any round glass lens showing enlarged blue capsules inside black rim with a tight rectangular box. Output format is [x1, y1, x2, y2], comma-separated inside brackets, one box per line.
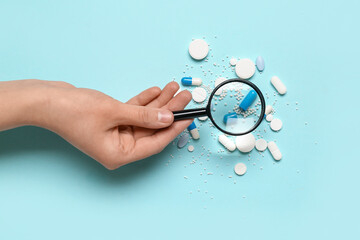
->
[210, 82, 265, 135]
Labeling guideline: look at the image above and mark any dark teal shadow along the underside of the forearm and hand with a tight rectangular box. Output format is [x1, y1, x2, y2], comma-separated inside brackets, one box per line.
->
[0, 126, 166, 185]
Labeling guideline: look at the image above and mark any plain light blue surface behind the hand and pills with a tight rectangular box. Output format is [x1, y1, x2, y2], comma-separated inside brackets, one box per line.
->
[0, 0, 360, 240]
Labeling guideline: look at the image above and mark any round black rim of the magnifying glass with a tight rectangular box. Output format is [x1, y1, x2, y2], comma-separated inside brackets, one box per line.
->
[206, 78, 266, 136]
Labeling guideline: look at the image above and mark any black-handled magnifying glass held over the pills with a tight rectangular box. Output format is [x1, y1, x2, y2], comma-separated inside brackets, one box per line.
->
[173, 78, 266, 136]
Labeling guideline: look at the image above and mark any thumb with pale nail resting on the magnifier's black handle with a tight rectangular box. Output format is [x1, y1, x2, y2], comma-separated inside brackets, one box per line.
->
[117, 103, 174, 129]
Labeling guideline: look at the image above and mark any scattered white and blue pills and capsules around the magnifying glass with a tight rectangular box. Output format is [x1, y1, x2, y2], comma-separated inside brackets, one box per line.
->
[177, 39, 287, 179]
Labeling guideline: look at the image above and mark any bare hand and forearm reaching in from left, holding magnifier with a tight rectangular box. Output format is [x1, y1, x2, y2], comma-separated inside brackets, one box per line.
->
[0, 79, 193, 170]
